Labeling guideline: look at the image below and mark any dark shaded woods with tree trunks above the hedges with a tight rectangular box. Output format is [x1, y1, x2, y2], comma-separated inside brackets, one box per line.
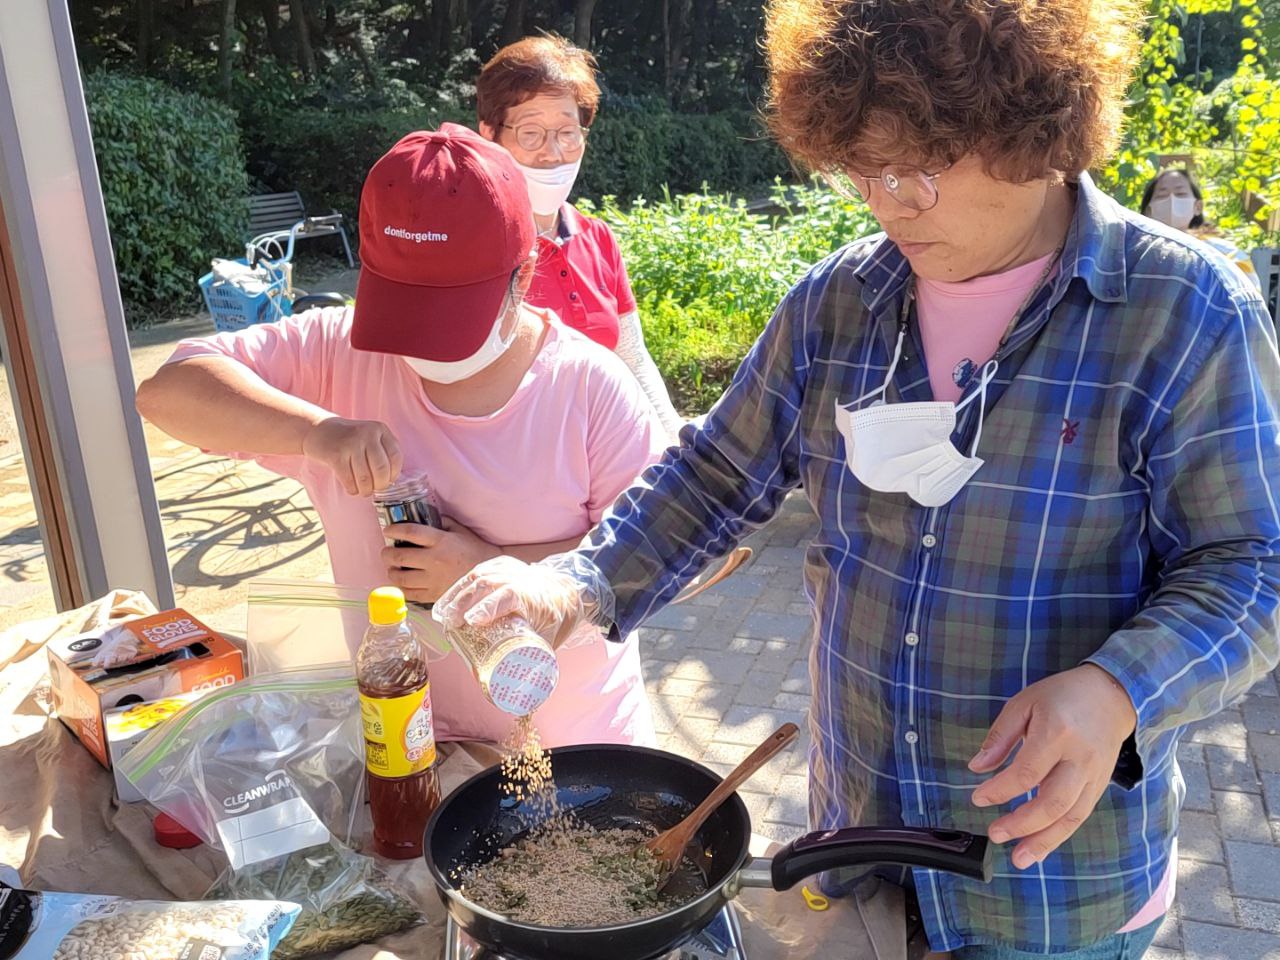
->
[70, 0, 763, 111]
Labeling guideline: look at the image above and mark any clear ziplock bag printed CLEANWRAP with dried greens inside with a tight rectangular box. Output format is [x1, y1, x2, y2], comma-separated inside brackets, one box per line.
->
[120, 663, 425, 960]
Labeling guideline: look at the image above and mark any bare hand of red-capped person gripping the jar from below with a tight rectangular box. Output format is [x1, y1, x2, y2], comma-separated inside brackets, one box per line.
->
[383, 517, 502, 603]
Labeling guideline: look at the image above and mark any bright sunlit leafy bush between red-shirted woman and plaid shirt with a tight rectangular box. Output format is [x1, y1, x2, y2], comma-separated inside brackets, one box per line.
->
[585, 184, 879, 412]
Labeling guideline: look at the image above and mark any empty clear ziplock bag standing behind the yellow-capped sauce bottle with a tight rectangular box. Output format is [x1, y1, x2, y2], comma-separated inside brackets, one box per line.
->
[246, 577, 449, 676]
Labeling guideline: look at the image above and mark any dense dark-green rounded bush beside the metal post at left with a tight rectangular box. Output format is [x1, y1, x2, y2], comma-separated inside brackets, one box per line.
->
[84, 72, 248, 317]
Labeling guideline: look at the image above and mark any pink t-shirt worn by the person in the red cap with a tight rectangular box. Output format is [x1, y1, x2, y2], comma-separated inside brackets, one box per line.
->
[169, 307, 664, 745]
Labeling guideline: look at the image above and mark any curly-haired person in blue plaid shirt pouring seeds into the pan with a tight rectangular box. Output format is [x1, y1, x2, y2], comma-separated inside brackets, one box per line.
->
[445, 0, 1280, 960]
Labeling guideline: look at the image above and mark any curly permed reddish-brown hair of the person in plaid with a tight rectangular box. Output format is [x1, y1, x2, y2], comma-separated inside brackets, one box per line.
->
[765, 0, 1142, 183]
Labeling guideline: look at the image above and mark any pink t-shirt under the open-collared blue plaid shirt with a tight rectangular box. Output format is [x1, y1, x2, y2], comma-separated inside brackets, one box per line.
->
[916, 253, 1178, 933]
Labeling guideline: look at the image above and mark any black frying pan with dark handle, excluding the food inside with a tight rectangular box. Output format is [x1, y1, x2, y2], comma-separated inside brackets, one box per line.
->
[422, 745, 991, 960]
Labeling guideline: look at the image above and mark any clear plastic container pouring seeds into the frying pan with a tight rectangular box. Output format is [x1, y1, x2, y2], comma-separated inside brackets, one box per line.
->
[436, 616, 559, 717]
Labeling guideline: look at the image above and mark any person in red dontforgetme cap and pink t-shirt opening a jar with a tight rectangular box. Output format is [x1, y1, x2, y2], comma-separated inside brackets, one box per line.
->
[137, 124, 666, 744]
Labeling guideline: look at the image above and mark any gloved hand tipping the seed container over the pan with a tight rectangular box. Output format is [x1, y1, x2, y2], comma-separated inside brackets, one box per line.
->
[431, 556, 588, 646]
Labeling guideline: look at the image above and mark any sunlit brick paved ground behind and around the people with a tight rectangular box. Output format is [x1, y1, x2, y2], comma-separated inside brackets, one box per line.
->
[0, 287, 1280, 960]
